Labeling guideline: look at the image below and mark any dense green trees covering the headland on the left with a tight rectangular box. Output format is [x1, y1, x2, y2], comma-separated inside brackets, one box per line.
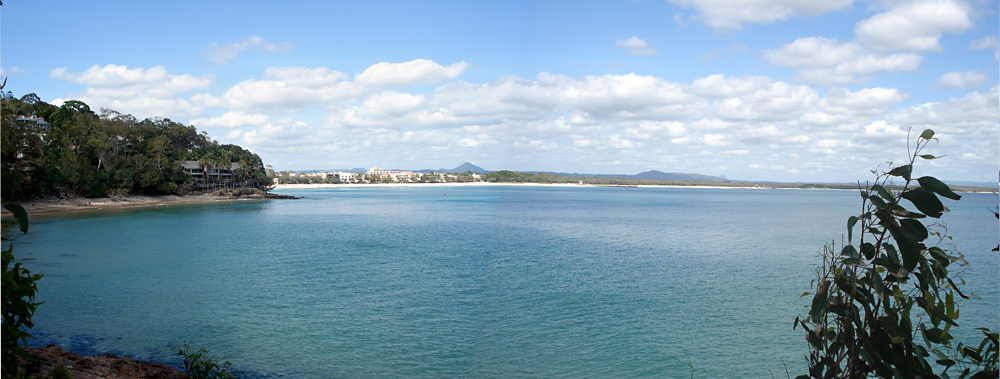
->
[0, 92, 270, 200]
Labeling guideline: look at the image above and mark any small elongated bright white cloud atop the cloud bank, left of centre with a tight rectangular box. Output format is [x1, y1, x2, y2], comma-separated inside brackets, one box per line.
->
[354, 59, 473, 88]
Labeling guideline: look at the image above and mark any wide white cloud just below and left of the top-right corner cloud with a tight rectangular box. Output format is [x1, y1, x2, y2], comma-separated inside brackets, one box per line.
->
[762, 37, 923, 85]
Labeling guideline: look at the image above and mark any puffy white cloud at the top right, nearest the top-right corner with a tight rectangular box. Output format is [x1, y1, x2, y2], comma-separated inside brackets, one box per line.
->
[854, 0, 973, 51]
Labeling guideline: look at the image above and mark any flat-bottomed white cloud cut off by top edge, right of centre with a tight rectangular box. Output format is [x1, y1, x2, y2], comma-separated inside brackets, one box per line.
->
[668, 0, 852, 31]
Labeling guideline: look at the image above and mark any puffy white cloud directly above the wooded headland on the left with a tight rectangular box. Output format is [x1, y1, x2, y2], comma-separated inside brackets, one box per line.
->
[49, 64, 215, 117]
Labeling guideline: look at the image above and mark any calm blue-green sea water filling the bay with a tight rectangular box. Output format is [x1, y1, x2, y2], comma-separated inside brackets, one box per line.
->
[9, 187, 1000, 378]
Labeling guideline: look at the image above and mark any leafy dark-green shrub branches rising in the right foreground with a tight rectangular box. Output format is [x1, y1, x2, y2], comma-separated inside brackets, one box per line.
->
[795, 129, 997, 379]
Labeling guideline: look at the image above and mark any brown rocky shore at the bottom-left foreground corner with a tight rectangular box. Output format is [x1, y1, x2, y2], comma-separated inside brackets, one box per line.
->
[18, 345, 185, 379]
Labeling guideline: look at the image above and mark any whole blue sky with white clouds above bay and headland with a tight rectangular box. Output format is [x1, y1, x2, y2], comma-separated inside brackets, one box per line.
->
[0, 0, 1000, 183]
